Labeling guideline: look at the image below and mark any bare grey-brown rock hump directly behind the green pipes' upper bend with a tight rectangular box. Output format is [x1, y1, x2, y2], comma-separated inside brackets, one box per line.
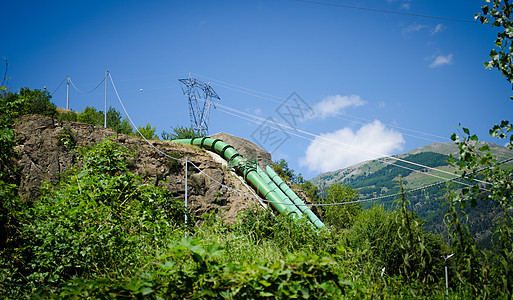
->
[210, 132, 272, 170]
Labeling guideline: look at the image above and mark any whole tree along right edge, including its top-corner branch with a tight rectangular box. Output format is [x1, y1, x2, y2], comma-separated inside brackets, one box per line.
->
[440, 0, 513, 299]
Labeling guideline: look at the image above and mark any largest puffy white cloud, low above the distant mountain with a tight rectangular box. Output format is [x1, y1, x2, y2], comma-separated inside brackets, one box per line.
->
[300, 120, 405, 172]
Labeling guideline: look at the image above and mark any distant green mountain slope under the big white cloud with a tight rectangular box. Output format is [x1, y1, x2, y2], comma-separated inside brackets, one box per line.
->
[310, 143, 513, 250]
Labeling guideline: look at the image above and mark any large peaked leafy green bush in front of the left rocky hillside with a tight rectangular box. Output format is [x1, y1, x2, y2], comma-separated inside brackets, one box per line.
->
[12, 141, 184, 285]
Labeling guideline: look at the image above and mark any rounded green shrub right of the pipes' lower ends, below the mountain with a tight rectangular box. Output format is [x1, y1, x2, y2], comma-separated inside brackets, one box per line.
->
[348, 202, 442, 288]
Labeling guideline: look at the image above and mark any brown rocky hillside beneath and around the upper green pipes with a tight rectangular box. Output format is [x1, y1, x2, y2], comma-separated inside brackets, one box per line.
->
[15, 115, 270, 222]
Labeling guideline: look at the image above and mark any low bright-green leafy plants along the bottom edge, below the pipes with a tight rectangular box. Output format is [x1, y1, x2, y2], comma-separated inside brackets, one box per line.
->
[55, 239, 353, 299]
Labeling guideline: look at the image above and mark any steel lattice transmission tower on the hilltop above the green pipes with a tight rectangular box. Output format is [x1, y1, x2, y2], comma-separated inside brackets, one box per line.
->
[178, 77, 221, 136]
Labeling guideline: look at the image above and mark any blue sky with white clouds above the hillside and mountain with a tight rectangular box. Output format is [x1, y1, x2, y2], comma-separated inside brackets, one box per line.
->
[0, 0, 513, 179]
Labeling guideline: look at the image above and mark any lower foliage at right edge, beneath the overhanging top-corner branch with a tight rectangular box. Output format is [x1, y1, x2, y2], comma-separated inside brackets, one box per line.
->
[446, 125, 513, 297]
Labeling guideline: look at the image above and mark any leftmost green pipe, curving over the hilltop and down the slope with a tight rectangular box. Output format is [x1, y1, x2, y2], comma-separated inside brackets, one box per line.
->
[173, 137, 300, 216]
